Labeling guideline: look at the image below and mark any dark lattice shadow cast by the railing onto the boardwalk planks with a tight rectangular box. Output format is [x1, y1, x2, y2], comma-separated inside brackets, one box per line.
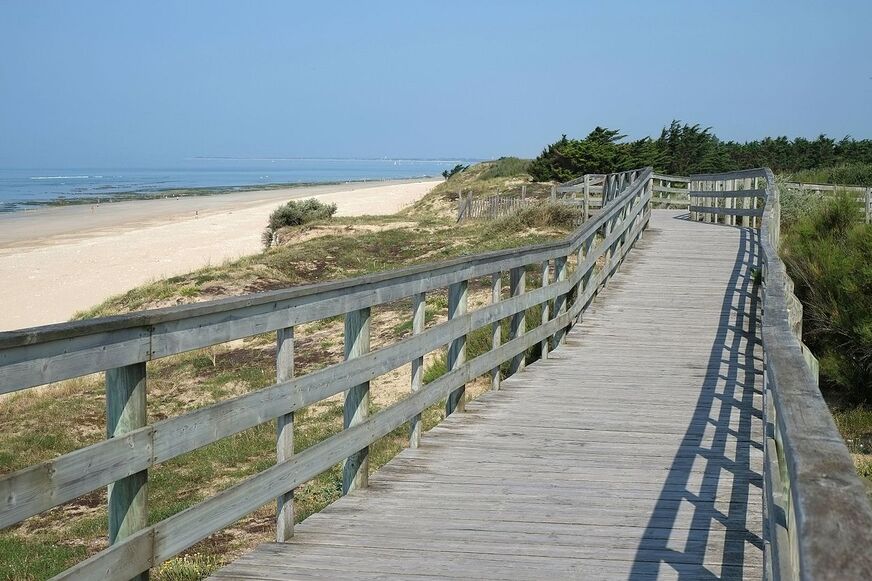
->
[630, 220, 763, 579]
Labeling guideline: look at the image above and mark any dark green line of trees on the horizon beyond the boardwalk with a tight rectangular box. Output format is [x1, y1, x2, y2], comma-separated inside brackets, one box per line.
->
[529, 121, 872, 181]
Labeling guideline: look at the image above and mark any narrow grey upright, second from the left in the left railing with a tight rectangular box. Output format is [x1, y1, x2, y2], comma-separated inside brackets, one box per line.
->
[276, 327, 294, 543]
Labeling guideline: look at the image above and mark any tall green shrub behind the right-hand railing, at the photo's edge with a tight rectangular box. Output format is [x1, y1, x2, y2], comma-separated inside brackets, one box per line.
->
[781, 194, 872, 403]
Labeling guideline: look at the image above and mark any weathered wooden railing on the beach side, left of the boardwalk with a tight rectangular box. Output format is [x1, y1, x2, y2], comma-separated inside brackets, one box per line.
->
[0, 168, 652, 579]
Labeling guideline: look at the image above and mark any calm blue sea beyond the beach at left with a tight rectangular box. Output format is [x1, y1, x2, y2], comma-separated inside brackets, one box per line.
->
[0, 159, 460, 212]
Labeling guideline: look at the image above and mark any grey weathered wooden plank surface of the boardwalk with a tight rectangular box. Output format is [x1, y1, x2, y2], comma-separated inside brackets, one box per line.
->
[215, 211, 763, 580]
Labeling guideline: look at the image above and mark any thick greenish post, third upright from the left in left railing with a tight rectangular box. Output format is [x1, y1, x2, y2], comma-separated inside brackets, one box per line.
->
[342, 307, 370, 494]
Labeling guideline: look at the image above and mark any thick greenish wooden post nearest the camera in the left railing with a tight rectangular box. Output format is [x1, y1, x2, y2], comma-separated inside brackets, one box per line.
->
[106, 363, 148, 581]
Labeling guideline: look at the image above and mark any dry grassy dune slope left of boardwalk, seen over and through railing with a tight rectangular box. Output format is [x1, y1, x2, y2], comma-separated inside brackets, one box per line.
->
[0, 159, 573, 580]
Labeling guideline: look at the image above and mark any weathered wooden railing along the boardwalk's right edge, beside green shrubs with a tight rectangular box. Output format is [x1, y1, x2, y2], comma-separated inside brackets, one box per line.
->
[690, 168, 872, 580]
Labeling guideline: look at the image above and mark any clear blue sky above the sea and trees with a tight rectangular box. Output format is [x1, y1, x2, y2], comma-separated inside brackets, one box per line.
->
[0, 0, 872, 167]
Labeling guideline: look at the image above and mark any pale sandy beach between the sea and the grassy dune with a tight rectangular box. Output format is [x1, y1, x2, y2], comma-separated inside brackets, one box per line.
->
[0, 180, 439, 331]
